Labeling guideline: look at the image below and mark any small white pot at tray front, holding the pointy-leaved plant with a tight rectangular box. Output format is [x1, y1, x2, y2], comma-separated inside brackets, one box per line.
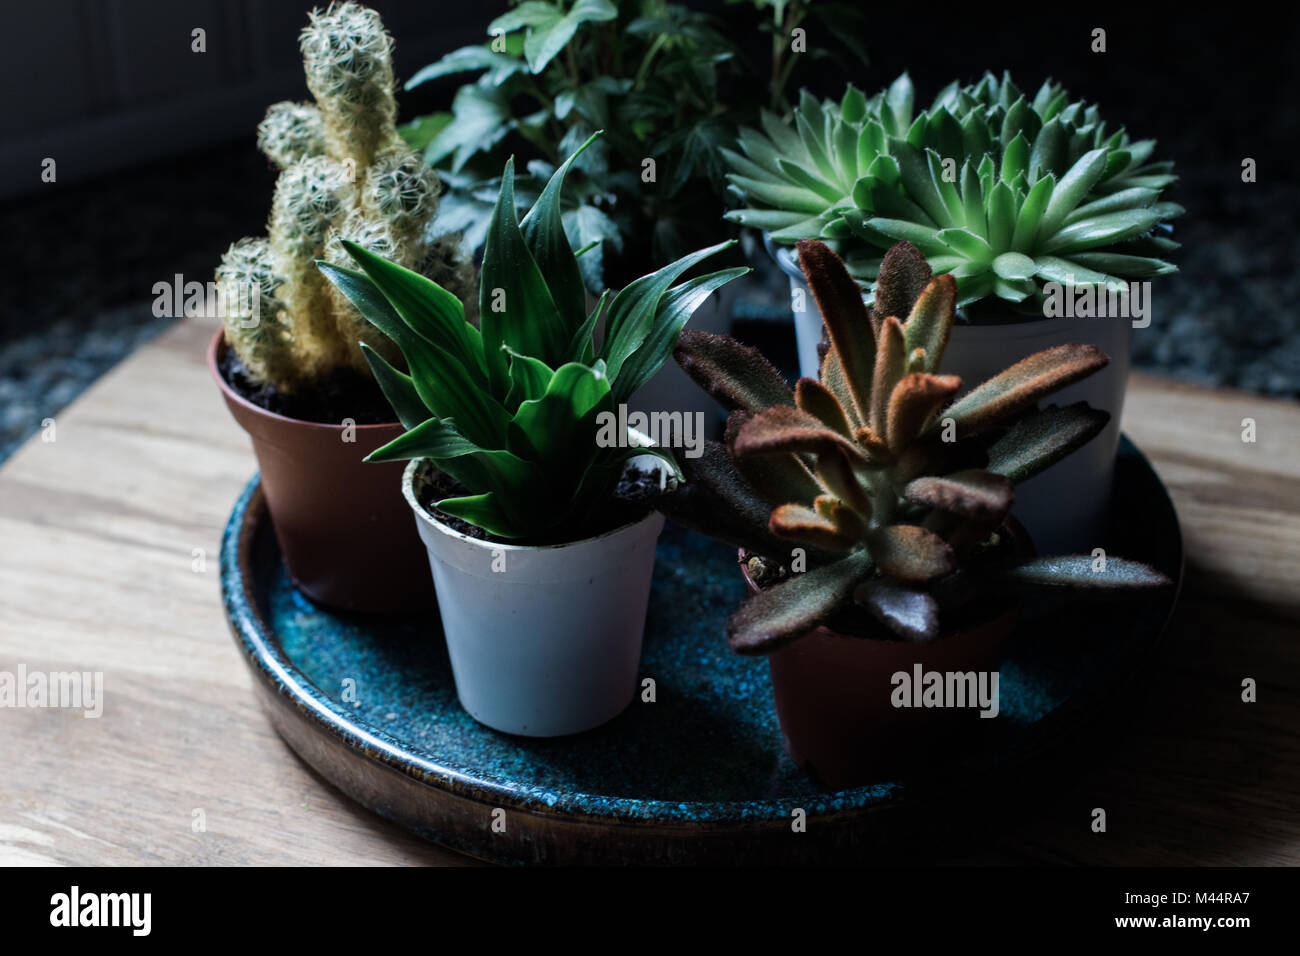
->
[402, 459, 663, 737]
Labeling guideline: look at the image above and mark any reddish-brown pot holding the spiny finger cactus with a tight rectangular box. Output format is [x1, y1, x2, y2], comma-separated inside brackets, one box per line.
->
[208, 329, 433, 611]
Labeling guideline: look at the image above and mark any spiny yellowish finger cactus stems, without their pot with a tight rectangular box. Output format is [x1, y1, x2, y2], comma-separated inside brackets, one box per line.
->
[217, 3, 477, 393]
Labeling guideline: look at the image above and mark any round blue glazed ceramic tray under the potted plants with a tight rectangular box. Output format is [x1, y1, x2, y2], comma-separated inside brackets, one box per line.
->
[221, 440, 1182, 864]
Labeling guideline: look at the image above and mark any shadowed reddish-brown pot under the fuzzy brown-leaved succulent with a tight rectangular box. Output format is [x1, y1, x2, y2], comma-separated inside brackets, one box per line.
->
[741, 524, 1032, 790]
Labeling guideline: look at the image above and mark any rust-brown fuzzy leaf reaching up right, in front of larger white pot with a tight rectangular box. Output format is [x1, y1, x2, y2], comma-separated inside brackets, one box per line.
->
[944, 345, 1110, 434]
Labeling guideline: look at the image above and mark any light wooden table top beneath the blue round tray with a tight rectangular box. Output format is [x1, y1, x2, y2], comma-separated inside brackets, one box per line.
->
[0, 320, 1300, 865]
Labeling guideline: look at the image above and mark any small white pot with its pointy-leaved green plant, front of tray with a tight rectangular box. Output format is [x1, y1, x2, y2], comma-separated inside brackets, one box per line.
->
[321, 130, 748, 736]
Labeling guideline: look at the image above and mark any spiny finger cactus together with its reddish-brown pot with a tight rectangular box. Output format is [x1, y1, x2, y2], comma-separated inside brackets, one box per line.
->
[208, 3, 473, 611]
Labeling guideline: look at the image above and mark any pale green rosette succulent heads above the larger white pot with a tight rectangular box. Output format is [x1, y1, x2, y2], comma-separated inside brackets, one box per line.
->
[724, 74, 1183, 317]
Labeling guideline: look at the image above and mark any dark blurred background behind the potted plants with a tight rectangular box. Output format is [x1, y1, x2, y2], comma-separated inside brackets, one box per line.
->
[0, 0, 1300, 459]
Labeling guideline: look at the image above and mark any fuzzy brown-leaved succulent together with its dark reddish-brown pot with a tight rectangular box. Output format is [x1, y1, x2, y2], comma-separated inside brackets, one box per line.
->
[659, 239, 1169, 788]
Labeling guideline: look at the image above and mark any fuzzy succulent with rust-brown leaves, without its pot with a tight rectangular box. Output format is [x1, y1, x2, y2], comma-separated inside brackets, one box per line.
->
[659, 239, 1169, 654]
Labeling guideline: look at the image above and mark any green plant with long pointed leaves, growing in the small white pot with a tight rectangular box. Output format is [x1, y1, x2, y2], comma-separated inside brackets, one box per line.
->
[320, 134, 748, 538]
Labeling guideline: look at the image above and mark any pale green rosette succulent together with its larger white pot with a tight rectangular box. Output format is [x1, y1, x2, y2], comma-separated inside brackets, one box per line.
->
[725, 74, 1182, 548]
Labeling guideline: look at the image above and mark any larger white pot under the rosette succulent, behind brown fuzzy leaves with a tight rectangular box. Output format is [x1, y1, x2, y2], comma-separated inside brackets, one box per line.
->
[764, 237, 1132, 554]
